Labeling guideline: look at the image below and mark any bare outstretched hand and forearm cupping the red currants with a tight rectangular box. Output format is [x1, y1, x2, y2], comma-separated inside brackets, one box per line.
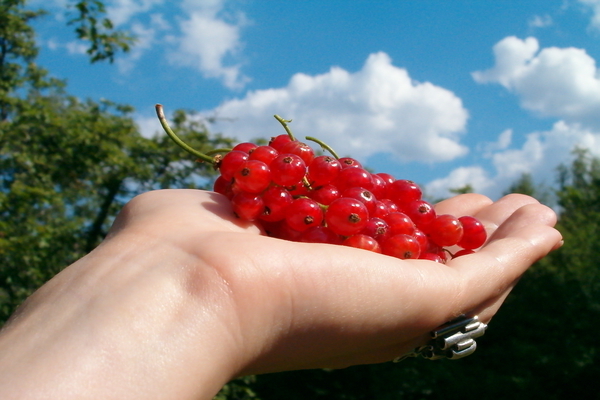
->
[0, 190, 562, 400]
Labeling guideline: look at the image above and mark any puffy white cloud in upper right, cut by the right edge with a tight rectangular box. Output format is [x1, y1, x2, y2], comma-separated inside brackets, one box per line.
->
[473, 36, 600, 127]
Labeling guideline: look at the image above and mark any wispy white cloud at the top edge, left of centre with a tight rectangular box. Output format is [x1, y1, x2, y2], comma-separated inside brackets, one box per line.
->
[169, 0, 249, 89]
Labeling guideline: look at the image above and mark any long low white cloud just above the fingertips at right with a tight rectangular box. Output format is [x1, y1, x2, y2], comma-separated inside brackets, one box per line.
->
[425, 121, 600, 198]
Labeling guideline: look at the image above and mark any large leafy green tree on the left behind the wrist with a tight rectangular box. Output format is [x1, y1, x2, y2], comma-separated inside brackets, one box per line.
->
[0, 0, 231, 321]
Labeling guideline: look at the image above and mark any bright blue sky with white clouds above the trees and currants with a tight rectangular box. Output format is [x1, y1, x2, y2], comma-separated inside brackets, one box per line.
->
[31, 0, 600, 198]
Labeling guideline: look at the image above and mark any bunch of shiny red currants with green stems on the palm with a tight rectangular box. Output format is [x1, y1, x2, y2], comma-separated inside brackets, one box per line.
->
[157, 106, 487, 263]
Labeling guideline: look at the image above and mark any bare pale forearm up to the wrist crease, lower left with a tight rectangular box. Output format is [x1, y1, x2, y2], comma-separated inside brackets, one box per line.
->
[0, 234, 235, 399]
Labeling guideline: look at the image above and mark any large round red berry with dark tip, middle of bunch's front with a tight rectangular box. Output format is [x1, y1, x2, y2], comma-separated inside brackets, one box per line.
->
[325, 197, 369, 236]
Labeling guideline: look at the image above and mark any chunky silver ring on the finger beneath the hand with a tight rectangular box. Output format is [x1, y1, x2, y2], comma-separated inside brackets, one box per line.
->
[394, 315, 487, 362]
